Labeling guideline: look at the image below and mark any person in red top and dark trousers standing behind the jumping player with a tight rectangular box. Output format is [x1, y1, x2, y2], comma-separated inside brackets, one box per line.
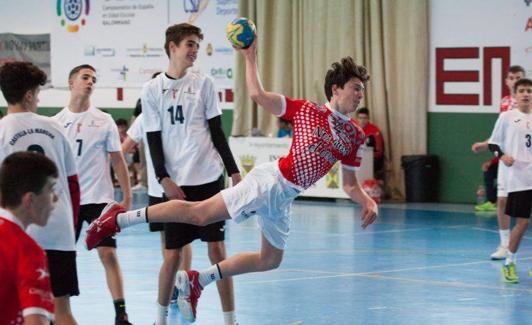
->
[356, 107, 384, 180]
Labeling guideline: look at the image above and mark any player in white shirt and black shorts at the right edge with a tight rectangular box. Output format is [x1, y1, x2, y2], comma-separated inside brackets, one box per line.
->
[489, 79, 532, 283]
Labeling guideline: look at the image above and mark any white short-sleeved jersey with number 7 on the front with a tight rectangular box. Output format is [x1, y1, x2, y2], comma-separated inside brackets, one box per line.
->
[53, 107, 122, 204]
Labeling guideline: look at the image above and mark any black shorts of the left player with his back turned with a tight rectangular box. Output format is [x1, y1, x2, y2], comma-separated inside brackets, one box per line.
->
[46, 250, 79, 298]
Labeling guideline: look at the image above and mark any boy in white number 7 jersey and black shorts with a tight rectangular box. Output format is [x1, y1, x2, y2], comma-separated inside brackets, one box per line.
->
[53, 65, 131, 324]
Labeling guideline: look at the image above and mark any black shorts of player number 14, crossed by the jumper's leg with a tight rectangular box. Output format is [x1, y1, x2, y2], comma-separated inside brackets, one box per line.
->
[164, 176, 225, 249]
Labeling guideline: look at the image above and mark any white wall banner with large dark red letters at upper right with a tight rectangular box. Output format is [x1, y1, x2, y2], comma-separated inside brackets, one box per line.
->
[429, 0, 532, 113]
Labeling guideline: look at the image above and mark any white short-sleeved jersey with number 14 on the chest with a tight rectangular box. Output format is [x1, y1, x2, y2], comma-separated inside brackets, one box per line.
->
[141, 69, 223, 185]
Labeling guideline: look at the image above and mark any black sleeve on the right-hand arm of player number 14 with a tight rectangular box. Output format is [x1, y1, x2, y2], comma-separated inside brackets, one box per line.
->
[207, 115, 242, 186]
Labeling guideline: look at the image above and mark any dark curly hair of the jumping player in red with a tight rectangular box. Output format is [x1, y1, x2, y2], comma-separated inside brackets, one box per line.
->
[324, 56, 369, 100]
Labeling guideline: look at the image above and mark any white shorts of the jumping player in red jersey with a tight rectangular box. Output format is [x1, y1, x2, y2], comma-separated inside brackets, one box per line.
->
[221, 161, 302, 250]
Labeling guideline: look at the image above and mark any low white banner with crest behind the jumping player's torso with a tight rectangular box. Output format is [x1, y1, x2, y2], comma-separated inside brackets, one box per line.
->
[229, 137, 373, 199]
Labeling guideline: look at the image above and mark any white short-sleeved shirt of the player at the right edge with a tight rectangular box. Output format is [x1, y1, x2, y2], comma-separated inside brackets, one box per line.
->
[489, 109, 532, 193]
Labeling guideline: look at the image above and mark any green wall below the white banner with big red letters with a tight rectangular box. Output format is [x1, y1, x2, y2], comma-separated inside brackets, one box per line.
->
[428, 113, 498, 203]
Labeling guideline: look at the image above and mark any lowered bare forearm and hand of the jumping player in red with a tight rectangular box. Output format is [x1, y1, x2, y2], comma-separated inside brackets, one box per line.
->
[342, 167, 379, 229]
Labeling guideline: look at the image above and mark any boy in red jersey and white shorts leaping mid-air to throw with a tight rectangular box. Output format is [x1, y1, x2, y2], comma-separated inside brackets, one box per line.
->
[87, 41, 377, 320]
